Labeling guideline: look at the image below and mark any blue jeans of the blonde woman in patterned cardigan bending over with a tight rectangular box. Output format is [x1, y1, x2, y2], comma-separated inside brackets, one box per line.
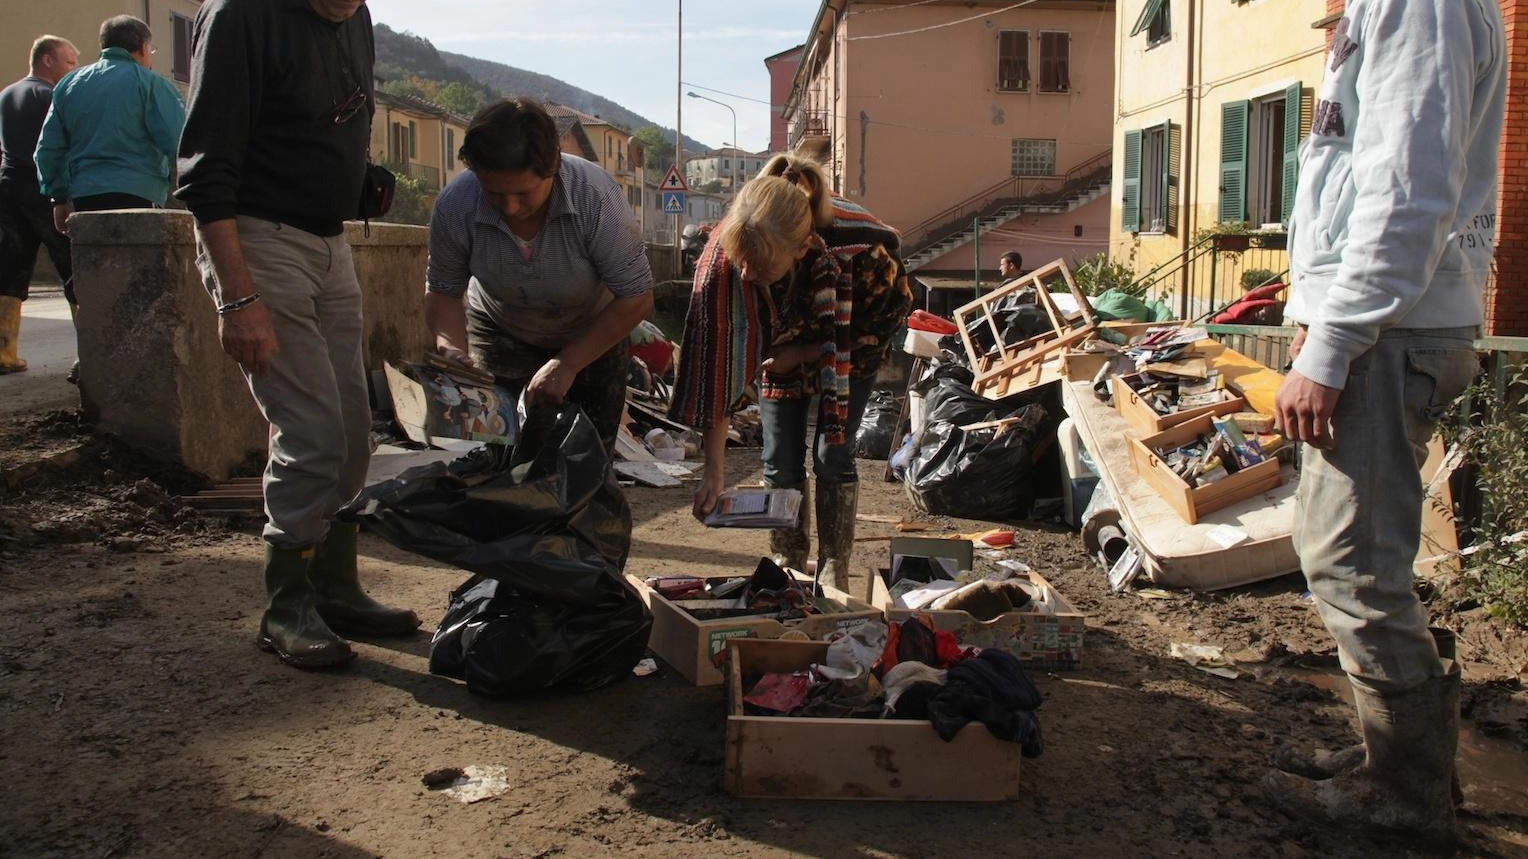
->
[759, 378, 876, 486]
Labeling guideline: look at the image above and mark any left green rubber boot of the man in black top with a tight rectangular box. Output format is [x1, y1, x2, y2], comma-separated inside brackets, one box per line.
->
[255, 543, 356, 668]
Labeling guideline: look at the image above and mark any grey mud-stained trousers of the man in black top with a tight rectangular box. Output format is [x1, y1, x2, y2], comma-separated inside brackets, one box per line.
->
[197, 216, 371, 547]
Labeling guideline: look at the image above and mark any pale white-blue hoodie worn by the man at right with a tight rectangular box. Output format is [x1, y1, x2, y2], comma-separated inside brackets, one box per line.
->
[1285, 0, 1507, 388]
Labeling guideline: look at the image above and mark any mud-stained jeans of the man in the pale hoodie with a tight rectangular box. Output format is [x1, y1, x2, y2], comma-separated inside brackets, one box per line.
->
[1294, 329, 1478, 692]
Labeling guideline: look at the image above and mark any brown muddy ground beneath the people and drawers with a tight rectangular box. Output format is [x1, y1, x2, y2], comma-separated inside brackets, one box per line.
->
[0, 413, 1528, 859]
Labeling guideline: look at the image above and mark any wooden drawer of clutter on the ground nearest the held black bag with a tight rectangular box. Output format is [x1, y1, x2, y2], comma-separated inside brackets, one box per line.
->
[626, 573, 882, 686]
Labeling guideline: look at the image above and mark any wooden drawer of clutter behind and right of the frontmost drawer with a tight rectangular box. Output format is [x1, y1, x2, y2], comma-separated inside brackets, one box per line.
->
[871, 572, 1088, 671]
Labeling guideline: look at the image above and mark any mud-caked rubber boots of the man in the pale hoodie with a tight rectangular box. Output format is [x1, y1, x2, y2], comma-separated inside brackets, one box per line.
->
[1262, 662, 1459, 845]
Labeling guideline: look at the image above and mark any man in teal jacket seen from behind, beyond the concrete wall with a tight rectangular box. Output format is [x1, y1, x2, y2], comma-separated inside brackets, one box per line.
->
[35, 15, 186, 234]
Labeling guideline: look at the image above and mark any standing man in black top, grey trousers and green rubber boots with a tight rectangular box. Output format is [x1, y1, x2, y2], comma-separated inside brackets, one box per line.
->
[176, 0, 419, 668]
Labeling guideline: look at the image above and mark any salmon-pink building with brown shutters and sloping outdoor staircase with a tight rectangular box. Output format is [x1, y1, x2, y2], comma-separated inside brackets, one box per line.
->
[772, 0, 1114, 273]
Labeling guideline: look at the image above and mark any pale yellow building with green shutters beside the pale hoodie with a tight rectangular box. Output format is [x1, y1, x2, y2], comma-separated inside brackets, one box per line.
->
[1109, 0, 1326, 316]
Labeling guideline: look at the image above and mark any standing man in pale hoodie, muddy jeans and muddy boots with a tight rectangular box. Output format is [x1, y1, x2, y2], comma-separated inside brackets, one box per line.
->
[1264, 0, 1507, 839]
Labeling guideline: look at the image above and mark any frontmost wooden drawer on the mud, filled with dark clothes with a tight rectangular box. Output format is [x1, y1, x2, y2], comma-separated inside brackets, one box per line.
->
[723, 639, 1021, 802]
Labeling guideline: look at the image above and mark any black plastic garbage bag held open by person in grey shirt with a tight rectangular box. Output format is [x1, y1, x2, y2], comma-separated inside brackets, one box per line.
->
[347, 407, 652, 697]
